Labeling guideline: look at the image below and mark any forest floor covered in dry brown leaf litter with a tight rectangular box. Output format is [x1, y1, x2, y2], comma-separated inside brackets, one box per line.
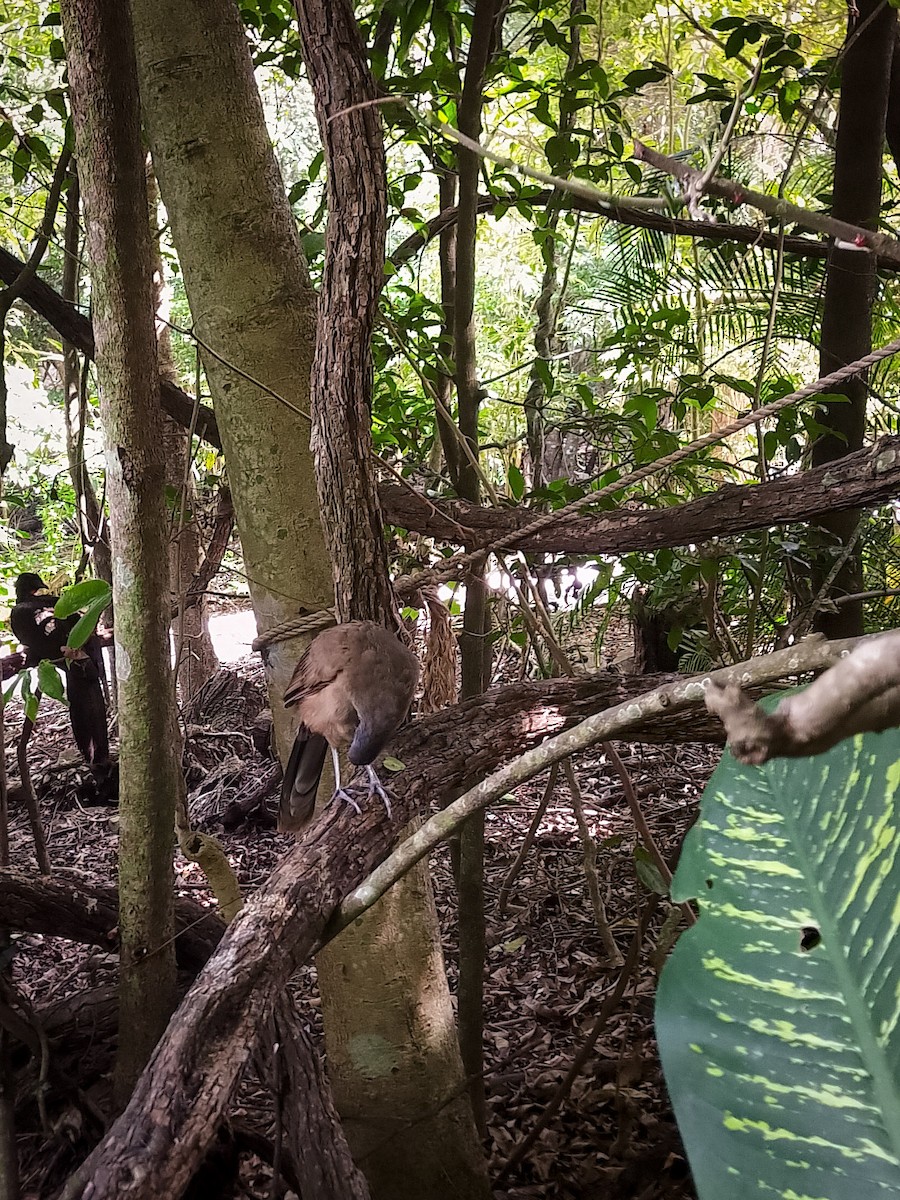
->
[6, 660, 719, 1200]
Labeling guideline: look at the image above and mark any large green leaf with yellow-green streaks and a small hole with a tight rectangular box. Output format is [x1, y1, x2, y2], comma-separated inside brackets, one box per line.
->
[656, 715, 900, 1200]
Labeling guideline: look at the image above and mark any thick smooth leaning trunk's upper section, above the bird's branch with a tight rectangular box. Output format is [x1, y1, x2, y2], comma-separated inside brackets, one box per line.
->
[132, 0, 332, 755]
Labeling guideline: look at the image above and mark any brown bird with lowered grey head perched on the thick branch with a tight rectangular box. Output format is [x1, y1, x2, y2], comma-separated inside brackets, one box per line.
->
[278, 620, 419, 832]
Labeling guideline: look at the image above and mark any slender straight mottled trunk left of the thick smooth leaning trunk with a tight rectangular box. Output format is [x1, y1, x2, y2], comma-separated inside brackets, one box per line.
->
[61, 0, 185, 1103]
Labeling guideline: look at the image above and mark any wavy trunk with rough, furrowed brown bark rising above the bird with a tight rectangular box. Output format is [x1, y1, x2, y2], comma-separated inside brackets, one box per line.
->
[296, 0, 394, 623]
